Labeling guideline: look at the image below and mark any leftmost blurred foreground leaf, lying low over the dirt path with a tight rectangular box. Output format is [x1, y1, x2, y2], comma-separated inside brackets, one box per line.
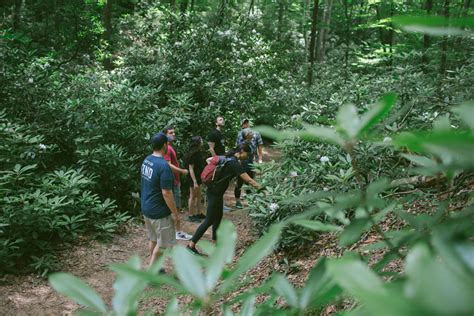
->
[49, 272, 107, 313]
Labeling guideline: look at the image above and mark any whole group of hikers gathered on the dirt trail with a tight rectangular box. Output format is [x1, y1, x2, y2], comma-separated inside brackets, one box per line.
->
[140, 116, 263, 266]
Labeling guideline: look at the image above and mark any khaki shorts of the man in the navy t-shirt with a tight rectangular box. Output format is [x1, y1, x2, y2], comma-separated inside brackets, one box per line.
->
[143, 215, 176, 248]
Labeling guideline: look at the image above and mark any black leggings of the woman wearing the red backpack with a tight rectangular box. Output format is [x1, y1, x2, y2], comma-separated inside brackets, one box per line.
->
[191, 190, 224, 243]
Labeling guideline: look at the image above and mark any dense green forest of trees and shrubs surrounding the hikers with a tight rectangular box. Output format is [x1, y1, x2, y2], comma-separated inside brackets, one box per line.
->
[0, 0, 474, 315]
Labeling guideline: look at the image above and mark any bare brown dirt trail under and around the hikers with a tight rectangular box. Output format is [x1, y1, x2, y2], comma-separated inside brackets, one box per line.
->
[0, 148, 288, 315]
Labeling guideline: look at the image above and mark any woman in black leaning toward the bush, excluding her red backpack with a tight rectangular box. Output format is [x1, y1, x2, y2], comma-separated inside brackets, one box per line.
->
[188, 143, 262, 255]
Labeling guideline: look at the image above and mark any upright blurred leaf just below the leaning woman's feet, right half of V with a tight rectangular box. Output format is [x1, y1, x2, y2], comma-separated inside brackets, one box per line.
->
[206, 220, 237, 292]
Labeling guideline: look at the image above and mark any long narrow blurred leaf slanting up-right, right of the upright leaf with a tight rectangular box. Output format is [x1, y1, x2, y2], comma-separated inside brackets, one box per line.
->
[220, 223, 284, 293]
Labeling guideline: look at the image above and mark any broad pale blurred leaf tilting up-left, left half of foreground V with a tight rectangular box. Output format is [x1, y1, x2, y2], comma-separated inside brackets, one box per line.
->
[172, 245, 207, 300]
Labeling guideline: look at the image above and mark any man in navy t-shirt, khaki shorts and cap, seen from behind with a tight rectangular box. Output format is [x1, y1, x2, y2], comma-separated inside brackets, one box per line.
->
[140, 133, 181, 266]
